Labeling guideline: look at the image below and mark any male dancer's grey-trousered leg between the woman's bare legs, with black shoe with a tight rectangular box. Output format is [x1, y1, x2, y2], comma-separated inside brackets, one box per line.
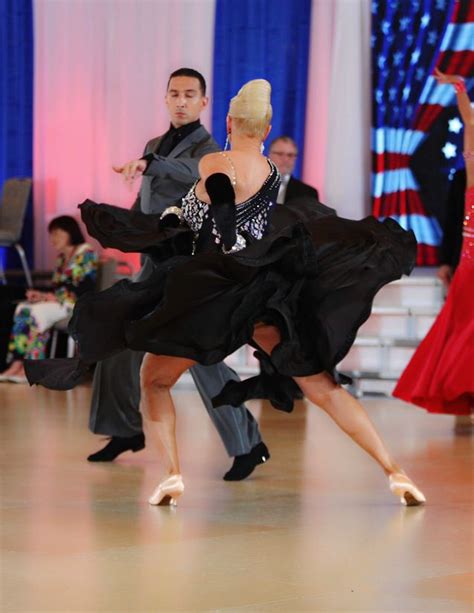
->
[189, 362, 270, 481]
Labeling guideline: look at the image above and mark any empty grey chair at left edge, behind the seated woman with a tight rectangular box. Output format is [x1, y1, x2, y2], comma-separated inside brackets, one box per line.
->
[0, 179, 33, 287]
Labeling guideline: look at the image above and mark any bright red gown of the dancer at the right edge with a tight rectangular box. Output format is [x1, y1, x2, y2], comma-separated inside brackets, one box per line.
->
[393, 187, 474, 415]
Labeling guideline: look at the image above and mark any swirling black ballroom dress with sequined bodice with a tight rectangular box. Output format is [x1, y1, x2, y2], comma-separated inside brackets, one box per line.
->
[26, 161, 416, 411]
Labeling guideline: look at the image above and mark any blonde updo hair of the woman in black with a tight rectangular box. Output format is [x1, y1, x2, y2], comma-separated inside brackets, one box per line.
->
[228, 79, 273, 140]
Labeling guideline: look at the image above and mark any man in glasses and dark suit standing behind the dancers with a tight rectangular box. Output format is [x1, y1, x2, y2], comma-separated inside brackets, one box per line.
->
[268, 136, 319, 204]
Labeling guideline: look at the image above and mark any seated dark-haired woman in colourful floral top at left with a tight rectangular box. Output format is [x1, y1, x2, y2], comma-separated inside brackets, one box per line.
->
[0, 215, 97, 383]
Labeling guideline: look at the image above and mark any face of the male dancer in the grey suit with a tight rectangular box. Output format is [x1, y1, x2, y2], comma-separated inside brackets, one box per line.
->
[165, 77, 208, 128]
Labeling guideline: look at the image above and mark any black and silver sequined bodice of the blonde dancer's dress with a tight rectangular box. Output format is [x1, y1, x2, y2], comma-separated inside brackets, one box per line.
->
[181, 160, 280, 253]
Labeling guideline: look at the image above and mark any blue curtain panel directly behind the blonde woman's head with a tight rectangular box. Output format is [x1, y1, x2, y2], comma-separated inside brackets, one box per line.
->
[212, 0, 311, 176]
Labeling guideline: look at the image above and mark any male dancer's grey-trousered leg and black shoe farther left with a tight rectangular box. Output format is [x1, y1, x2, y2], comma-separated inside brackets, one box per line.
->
[88, 350, 145, 462]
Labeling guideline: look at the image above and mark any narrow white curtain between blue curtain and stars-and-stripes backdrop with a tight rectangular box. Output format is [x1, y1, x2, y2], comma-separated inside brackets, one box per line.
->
[303, 0, 371, 219]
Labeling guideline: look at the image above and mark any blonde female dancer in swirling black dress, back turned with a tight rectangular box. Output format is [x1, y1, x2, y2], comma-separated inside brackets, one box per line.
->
[28, 79, 425, 505]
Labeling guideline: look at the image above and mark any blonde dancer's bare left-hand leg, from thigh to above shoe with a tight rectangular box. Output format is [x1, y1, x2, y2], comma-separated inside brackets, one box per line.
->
[140, 353, 195, 475]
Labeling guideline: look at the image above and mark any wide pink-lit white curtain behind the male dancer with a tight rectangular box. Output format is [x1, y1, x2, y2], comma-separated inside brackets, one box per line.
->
[33, 0, 215, 268]
